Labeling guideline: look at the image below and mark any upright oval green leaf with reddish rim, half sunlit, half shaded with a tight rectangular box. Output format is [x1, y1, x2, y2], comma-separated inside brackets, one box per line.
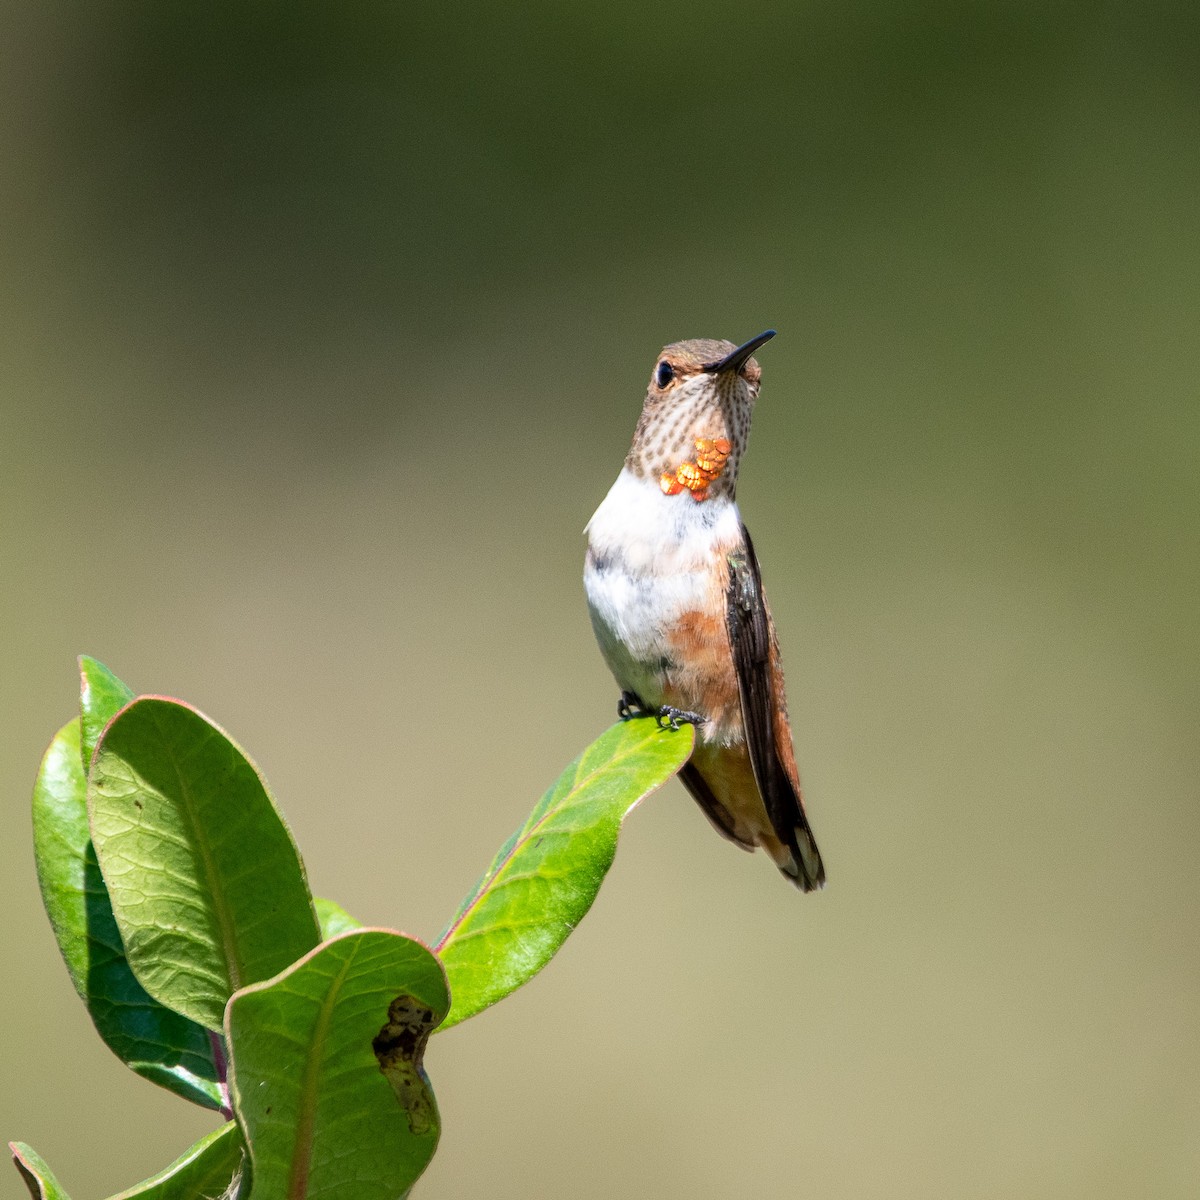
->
[88, 696, 320, 1030]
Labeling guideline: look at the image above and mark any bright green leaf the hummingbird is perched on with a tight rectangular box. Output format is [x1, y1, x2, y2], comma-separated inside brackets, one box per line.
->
[433, 718, 695, 1028]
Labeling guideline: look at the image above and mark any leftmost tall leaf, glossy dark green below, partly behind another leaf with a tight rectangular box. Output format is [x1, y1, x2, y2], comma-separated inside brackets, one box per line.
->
[34, 718, 221, 1109]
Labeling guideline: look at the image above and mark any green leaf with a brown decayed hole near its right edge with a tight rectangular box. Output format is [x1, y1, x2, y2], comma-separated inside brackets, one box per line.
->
[226, 929, 449, 1200]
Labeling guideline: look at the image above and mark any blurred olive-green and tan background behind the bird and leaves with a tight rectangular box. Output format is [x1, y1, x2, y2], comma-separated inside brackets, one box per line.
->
[0, 0, 1200, 1200]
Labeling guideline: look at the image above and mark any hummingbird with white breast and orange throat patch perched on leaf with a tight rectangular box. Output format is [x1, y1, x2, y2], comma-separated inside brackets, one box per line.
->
[583, 329, 824, 892]
